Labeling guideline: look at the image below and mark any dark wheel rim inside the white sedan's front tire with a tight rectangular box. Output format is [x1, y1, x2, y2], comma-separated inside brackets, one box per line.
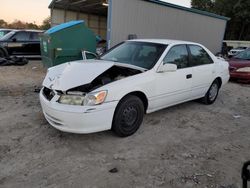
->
[122, 106, 138, 127]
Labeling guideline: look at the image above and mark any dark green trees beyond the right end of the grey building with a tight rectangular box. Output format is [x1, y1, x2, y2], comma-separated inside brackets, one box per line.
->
[191, 0, 250, 40]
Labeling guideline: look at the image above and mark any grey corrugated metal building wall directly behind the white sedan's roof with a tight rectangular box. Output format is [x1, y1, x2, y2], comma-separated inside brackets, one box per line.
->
[111, 0, 226, 53]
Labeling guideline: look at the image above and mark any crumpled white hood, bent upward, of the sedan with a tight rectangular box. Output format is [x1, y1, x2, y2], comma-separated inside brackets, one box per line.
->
[43, 60, 115, 91]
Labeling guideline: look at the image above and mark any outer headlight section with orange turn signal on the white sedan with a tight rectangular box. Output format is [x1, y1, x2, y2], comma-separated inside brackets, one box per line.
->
[84, 91, 108, 106]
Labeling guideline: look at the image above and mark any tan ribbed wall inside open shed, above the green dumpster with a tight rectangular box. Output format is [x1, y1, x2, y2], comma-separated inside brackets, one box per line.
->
[51, 9, 107, 39]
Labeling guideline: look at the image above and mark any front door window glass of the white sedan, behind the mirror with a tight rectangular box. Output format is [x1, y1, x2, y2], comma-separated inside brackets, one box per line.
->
[163, 45, 188, 69]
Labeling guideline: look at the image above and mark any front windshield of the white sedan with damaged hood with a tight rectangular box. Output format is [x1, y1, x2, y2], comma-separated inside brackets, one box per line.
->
[100, 41, 167, 70]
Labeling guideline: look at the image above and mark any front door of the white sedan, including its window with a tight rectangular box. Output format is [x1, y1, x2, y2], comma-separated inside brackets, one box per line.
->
[151, 44, 192, 109]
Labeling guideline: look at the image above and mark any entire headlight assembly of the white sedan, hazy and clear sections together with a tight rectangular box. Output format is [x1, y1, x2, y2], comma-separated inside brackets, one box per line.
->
[58, 91, 108, 106]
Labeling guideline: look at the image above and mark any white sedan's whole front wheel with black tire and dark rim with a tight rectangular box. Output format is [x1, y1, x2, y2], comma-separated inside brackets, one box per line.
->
[112, 95, 144, 137]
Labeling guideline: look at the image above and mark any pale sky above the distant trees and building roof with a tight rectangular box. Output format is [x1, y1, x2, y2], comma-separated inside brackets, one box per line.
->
[0, 0, 190, 25]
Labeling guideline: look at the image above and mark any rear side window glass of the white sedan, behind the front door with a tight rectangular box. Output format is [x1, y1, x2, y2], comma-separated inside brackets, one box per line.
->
[189, 45, 213, 66]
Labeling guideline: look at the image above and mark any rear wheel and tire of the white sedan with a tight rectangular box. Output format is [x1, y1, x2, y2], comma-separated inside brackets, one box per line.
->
[202, 80, 220, 105]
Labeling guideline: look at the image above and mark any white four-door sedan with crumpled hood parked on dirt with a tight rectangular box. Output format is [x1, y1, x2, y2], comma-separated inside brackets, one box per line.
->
[40, 40, 229, 137]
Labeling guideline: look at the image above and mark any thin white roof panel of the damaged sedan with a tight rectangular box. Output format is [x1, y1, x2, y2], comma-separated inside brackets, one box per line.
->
[128, 39, 200, 45]
